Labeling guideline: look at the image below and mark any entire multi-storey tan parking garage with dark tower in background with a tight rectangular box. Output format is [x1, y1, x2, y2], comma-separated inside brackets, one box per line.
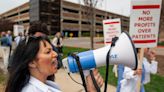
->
[0, 0, 164, 39]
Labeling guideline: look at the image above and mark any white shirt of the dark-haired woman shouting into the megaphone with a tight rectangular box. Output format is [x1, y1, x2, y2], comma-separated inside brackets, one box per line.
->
[21, 76, 61, 92]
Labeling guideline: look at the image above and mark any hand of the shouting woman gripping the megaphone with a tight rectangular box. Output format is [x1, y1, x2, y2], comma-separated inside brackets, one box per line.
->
[86, 69, 104, 92]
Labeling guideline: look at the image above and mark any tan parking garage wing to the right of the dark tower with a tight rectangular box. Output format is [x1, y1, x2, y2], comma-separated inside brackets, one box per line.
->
[61, 1, 129, 36]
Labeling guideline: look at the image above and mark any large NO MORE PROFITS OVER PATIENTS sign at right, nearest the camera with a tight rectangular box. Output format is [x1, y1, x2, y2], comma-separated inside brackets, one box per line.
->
[130, 0, 161, 48]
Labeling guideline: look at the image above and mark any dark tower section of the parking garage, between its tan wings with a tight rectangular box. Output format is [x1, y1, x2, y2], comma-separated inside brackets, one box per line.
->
[30, 0, 61, 34]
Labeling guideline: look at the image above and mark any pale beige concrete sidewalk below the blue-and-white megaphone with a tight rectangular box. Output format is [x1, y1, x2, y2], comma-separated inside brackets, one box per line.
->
[55, 69, 116, 92]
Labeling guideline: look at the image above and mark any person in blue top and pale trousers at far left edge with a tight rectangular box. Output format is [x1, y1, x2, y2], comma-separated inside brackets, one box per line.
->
[0, 32, 10, 73]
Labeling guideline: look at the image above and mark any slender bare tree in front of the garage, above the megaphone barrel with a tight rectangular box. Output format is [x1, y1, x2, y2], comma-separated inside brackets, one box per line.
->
[80, 0, 103, 49]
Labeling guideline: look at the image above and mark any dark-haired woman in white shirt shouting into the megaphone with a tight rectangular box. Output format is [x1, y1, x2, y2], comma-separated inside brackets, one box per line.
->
[5, 29, 103, 92]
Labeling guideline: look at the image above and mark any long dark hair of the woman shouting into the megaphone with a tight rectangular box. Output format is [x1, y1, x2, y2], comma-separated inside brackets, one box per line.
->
[5, 36, 50, 92]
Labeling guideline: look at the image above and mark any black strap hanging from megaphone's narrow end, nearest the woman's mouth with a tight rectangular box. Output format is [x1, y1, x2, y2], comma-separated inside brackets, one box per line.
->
[71, 53, 87, 92]
